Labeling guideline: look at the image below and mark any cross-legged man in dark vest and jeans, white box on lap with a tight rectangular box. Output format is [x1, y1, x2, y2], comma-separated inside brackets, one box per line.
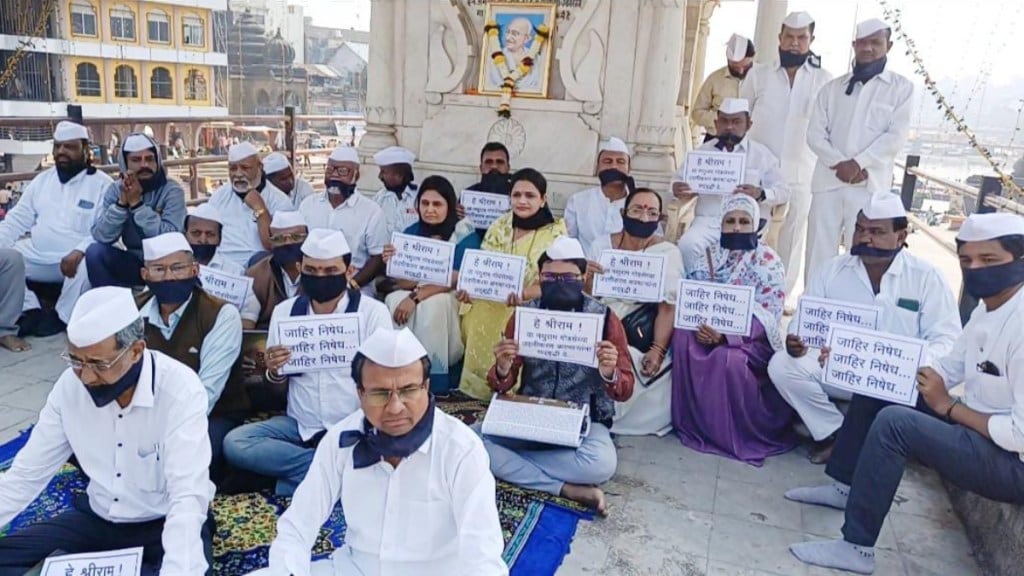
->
[483, 236, 634, 515]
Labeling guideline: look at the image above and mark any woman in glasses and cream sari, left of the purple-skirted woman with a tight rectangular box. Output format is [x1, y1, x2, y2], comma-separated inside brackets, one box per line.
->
[589, 188, 683, 436]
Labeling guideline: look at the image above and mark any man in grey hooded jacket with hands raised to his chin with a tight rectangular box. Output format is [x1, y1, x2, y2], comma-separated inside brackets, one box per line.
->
[85, 134, 185, 288]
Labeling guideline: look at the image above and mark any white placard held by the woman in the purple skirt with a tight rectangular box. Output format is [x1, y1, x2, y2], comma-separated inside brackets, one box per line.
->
[676, 280, 756, 336]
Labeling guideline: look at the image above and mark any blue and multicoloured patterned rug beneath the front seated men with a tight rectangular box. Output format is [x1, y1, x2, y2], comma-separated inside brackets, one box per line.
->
[0, 395, 593, 576]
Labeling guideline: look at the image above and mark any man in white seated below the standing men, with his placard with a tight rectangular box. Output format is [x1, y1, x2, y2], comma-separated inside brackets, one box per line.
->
[672, 98, 790, 271]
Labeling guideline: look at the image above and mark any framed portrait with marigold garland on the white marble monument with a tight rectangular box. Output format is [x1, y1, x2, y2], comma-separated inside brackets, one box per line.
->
[477, 2, 556, 98]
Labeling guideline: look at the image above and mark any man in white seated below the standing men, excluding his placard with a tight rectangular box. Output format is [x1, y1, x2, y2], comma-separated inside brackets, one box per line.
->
[672, 98, 790, 271]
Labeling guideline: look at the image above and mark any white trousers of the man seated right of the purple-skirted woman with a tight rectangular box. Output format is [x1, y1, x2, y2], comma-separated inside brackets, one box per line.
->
[768, 348, 852, 441]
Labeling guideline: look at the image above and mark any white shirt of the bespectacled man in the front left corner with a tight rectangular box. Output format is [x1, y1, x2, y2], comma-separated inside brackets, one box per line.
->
[0, 351, 214, 576]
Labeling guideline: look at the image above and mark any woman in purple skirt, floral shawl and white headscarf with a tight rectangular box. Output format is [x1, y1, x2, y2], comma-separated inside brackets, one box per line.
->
[672, 194, 796, 466]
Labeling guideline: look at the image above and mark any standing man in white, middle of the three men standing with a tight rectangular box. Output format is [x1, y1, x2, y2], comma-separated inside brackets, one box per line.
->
[739, 12, 833, 295]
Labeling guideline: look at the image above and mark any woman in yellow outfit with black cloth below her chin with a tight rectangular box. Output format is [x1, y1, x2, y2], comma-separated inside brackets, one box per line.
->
[458, 168, 566, 400]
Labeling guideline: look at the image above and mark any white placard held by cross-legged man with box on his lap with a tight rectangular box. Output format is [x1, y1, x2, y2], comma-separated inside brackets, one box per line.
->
[515, 306, 604, 368]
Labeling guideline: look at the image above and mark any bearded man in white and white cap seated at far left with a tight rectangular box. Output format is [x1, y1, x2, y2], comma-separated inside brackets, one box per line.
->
[0, 121, 112, 342]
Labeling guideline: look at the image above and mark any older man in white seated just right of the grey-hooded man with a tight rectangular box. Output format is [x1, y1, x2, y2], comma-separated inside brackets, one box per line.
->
[204, 141, 292, 270]
